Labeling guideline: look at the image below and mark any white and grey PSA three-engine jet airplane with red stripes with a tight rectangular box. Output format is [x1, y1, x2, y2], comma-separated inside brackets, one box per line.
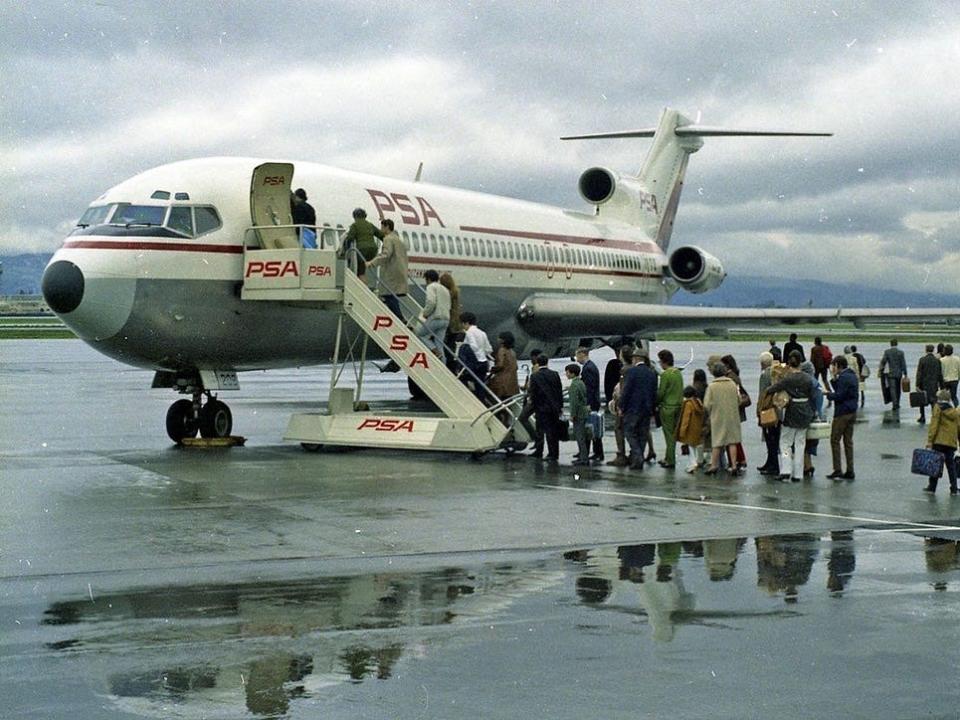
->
[42, 108, 960, 442]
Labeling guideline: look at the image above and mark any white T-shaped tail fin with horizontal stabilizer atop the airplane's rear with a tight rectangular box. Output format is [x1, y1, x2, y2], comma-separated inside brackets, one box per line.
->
[561, 108, 833, 250]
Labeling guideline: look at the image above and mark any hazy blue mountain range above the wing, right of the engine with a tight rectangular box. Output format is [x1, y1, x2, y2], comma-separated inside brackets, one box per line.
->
[670, 276, 960, 308]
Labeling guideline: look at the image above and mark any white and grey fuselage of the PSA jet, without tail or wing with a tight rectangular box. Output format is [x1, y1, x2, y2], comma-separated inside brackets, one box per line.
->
[44, 158, 671, 371]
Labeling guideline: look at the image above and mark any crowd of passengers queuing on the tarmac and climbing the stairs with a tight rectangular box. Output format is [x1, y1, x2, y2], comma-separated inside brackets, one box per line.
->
[320, 205, 960, 494]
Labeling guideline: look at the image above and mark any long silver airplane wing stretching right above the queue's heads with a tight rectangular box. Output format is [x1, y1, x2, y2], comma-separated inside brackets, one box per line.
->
[517, 294, 960, 337]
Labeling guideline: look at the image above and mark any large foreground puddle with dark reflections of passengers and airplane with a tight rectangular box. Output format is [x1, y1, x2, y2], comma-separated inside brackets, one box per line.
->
[35, 531, 960, 717]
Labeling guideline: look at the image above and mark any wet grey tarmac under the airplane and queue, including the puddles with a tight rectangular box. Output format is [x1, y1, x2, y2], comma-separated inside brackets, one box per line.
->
[0, 340, 960, 718]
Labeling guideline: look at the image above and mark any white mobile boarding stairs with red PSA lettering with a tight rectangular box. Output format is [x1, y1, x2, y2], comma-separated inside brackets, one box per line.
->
[241, 248, 527, 454]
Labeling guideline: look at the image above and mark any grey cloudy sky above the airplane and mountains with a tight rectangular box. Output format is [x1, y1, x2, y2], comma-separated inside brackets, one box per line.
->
[0, 0, 960, 292]
